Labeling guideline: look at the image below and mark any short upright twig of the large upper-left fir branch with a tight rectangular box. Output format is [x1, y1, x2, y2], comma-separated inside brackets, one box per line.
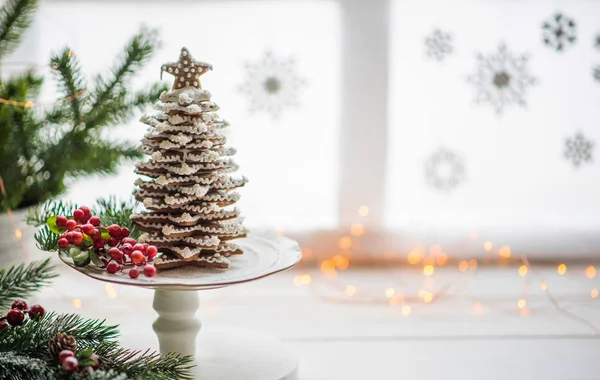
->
[50, 48, 86, 127]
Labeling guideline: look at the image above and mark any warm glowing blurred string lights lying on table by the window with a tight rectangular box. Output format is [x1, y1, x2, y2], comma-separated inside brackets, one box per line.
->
[294, 206, 600, 333]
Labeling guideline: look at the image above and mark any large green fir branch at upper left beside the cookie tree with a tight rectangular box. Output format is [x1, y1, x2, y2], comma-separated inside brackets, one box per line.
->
[0, 23, 167, 213]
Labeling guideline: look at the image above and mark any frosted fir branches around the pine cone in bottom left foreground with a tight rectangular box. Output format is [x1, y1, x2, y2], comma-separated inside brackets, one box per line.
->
[0, 313, 193, 380]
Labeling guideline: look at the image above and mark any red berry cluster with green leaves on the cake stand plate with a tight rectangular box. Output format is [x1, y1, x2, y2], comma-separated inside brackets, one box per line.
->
[49, 206, 158, 278]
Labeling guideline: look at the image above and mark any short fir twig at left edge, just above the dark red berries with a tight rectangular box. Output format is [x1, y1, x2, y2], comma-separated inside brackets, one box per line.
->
[0, 259, 57, 309]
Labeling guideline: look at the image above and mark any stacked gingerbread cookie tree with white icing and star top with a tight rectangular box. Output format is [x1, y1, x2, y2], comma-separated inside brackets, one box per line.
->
[131, 48, 246, 269]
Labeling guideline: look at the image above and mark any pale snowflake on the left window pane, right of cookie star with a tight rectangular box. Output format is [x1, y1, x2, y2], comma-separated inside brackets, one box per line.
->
[239, 51, 306, 119]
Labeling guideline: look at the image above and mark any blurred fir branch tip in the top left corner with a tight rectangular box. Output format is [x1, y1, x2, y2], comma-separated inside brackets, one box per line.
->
[0, 0, 37, 58]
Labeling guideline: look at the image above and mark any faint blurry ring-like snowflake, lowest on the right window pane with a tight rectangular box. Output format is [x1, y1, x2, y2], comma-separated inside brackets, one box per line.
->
[425, 148, 466, 192]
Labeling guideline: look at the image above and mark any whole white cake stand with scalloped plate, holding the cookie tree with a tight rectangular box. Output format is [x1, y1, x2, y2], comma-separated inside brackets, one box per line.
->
[65, 232, 302, 380]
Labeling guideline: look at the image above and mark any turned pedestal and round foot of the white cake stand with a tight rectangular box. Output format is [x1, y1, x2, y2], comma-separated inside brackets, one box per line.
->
[152, 290, 298, 380]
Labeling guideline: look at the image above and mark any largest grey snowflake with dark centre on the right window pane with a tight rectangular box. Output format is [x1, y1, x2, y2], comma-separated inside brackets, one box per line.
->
[467, 43, 537, 114]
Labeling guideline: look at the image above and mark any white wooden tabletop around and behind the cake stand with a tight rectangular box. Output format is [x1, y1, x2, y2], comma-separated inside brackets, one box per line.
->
[39, 267, 600, 380]
